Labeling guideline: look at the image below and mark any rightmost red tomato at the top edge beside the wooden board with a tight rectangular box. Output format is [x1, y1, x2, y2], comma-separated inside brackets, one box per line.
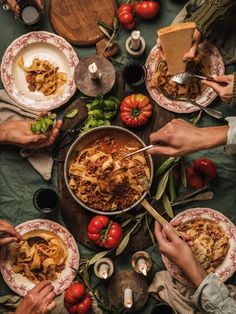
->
[134, 0, 160, 19]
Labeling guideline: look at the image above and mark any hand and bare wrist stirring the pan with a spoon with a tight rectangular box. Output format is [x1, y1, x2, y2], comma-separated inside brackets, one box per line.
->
[148, 119, 229, 156]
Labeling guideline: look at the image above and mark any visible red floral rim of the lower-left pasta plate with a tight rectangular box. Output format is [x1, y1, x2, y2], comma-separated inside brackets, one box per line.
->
[1, 219, 80, 296]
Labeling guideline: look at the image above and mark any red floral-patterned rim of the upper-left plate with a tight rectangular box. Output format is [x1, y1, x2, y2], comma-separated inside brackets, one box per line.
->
[1, 31, 79, 111]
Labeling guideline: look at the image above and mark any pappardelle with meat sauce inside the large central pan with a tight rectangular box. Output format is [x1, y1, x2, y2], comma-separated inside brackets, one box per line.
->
[68, 136, 150, 211]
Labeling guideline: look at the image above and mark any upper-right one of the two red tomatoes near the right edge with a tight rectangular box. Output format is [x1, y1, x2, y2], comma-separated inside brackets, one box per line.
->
[193, 158, 217, 182]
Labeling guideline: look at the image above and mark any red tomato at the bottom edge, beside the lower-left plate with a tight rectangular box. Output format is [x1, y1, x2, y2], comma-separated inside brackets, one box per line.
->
[64, 283, 92, 314]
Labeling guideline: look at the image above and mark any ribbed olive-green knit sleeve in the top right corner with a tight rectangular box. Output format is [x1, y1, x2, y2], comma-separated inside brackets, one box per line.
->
[185, 0, 236, 35]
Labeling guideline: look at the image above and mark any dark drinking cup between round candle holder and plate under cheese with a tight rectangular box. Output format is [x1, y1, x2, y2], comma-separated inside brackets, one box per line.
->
[122, 62, 147, 87]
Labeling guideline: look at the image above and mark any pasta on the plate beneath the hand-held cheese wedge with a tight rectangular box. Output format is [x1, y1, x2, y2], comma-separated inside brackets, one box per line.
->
[150, 54, 209, 100]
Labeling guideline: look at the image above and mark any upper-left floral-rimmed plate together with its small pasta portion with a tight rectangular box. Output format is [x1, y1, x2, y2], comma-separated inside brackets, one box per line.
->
[1, 31, 79, 111]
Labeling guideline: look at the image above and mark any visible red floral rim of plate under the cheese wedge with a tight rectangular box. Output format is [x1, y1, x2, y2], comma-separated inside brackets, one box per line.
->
[146, 41, 224, 113]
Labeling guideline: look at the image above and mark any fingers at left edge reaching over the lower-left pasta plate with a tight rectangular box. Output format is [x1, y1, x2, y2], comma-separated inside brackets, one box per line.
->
[0, 220, 21, 246]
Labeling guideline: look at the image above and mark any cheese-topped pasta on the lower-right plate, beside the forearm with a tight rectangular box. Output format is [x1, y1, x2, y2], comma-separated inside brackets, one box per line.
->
[178, 219, 229, 273]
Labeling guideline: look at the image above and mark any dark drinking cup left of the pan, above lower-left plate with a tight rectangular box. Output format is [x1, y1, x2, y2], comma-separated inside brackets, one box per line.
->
[33, 189, 60, 214]
